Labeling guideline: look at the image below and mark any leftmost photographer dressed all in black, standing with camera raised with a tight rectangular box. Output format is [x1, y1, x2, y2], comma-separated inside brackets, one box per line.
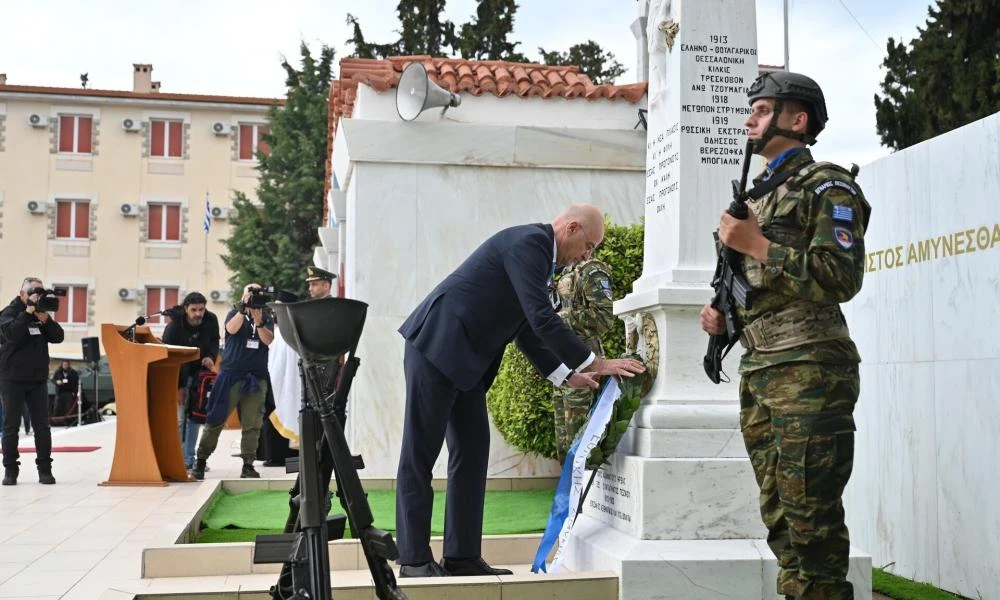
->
[0, 277, 64, 485]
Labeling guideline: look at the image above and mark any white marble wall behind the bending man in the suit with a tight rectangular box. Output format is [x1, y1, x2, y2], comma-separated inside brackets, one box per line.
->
[345, 158, 643, 477]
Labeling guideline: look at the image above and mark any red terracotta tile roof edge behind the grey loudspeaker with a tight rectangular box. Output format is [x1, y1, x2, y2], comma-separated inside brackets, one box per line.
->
[323, 56, 648, 212]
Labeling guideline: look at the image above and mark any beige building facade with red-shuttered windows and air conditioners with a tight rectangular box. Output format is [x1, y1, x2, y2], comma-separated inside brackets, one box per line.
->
[0, 64, 280, 356]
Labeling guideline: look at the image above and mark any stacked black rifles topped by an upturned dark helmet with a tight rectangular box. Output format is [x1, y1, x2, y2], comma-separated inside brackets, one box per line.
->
[254, 298, 406, 600]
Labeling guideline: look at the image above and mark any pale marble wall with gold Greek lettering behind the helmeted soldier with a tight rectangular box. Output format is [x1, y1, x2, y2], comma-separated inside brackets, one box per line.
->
[845, 114, 1000, 598]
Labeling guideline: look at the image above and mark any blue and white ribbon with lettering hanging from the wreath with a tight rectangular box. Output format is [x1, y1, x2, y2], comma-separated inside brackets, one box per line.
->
[531, 377, 621, 573]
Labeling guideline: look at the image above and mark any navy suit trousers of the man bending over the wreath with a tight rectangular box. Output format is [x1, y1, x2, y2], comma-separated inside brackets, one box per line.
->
[396, 342, 490, 565]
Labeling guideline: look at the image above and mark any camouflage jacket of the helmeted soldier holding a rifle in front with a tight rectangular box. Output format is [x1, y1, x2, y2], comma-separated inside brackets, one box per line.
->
[740, 149, 871, 373]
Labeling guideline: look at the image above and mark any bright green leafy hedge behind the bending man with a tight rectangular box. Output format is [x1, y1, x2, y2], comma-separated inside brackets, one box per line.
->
[486, 220, 643, 458]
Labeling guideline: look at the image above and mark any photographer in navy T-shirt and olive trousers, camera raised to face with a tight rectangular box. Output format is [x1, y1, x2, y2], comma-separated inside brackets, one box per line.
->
[191, 283, 274, 479]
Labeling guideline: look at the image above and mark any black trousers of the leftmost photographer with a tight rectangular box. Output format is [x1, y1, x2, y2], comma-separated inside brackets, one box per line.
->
[0, 381, 52, 473]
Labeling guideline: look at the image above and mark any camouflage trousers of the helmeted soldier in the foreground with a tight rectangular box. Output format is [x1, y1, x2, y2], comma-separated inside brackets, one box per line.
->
[740, 362, 860, 600]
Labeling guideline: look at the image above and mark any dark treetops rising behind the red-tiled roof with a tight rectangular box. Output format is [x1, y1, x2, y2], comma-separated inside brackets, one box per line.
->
[347, 0, 626, 84]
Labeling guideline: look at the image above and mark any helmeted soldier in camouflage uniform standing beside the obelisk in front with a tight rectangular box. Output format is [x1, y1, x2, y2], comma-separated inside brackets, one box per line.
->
[701, 72, 871, 600]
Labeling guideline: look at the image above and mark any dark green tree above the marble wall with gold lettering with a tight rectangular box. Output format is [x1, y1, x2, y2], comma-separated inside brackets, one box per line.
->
[875, 0, 1000, 150]
